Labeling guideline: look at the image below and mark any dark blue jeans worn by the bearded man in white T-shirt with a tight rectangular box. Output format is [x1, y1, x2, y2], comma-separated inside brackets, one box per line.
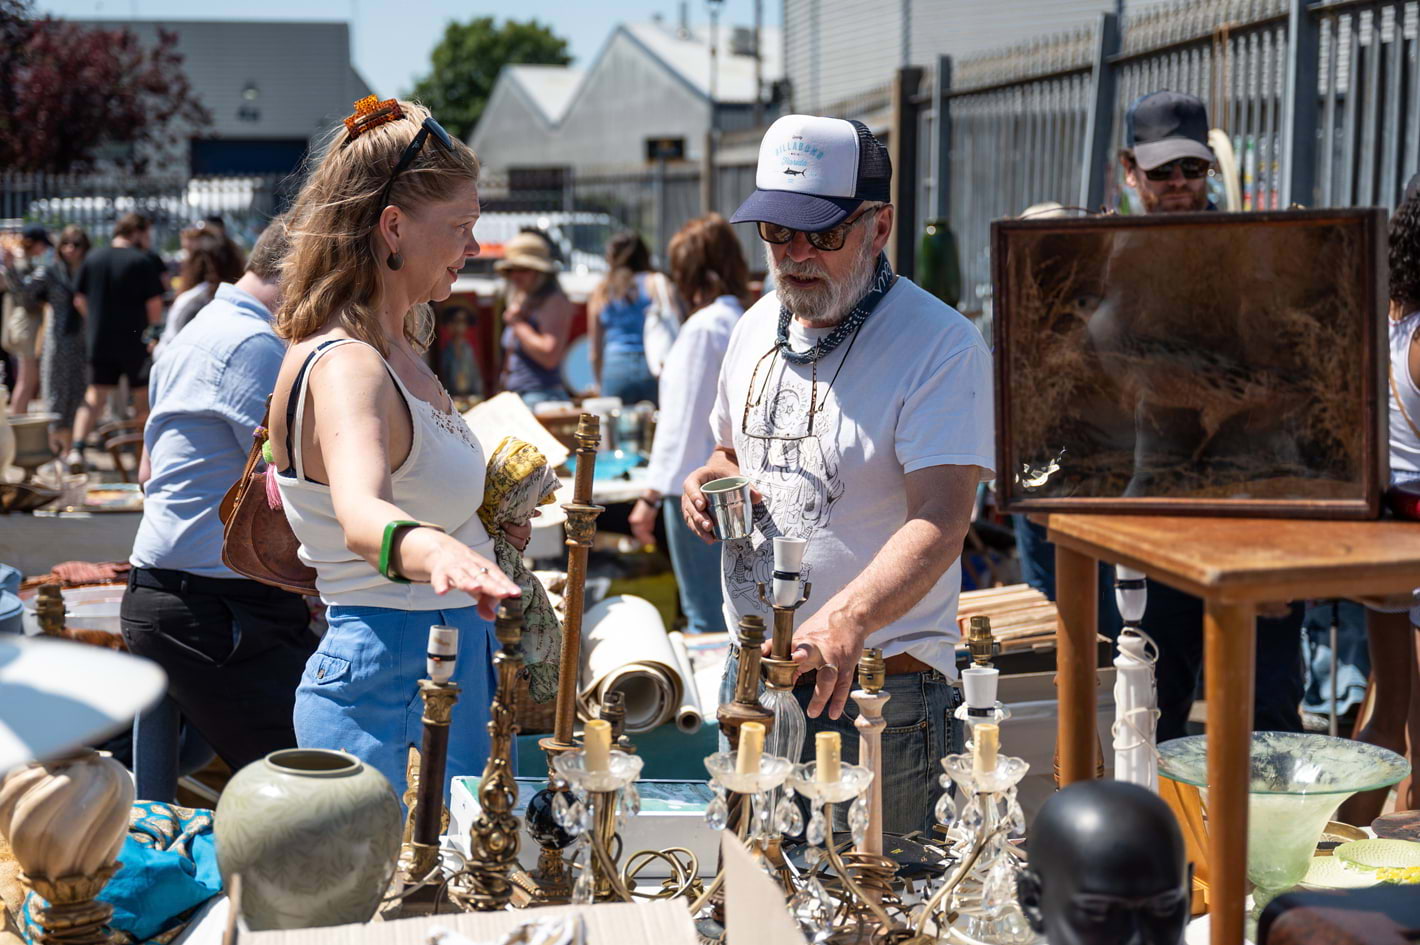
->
[720, 647, 966, 836]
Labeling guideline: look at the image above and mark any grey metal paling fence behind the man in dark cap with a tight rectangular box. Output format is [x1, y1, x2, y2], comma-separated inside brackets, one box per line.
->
[916, 0, 1420, 313]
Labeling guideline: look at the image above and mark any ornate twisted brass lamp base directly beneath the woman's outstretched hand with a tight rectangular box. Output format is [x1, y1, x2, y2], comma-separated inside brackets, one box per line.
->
[456, 603, 523, 912]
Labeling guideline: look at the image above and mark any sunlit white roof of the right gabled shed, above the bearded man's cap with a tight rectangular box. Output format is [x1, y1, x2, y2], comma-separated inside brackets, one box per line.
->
[619, 23, 784, 104]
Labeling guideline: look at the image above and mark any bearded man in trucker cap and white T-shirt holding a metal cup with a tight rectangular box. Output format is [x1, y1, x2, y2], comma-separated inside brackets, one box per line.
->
[682, 115, 994, 834]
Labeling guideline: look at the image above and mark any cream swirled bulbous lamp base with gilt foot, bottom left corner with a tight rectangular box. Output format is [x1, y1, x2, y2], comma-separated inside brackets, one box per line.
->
[0, 749, 133, 945]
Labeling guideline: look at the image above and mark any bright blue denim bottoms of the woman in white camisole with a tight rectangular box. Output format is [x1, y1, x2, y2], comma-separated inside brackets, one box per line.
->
[295, 604, 498, 803]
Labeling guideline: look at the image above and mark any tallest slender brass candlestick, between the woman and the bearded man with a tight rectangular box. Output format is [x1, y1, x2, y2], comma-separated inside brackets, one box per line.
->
[525, 414, 604, 905]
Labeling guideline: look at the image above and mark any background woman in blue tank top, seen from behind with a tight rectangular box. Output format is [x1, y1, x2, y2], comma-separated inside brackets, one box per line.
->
[586, 232, 657, 404]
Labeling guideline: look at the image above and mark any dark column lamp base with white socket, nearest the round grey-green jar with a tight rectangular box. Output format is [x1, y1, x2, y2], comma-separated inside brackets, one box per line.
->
[399, 625, 460, 885]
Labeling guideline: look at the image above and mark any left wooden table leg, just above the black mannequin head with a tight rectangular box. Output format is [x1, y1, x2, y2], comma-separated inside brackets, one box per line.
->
[1055, 544, 1099, 787]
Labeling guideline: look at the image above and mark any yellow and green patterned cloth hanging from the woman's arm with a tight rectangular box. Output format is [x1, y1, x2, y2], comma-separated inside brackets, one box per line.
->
[479, 436, 562, 702]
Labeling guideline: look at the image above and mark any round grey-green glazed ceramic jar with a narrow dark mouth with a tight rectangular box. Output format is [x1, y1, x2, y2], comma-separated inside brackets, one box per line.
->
[214, 747, 402, 931]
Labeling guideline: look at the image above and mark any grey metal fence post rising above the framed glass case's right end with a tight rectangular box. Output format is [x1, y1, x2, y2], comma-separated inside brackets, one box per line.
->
[1281, 0, 1323, 207]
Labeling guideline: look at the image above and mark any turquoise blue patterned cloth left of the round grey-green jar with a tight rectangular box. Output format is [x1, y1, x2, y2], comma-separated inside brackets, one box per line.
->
[20, 800, 222, 945]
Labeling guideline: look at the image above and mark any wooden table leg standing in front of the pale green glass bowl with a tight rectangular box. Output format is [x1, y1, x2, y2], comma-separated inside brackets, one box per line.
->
[1203, 601, 1257, 945]
